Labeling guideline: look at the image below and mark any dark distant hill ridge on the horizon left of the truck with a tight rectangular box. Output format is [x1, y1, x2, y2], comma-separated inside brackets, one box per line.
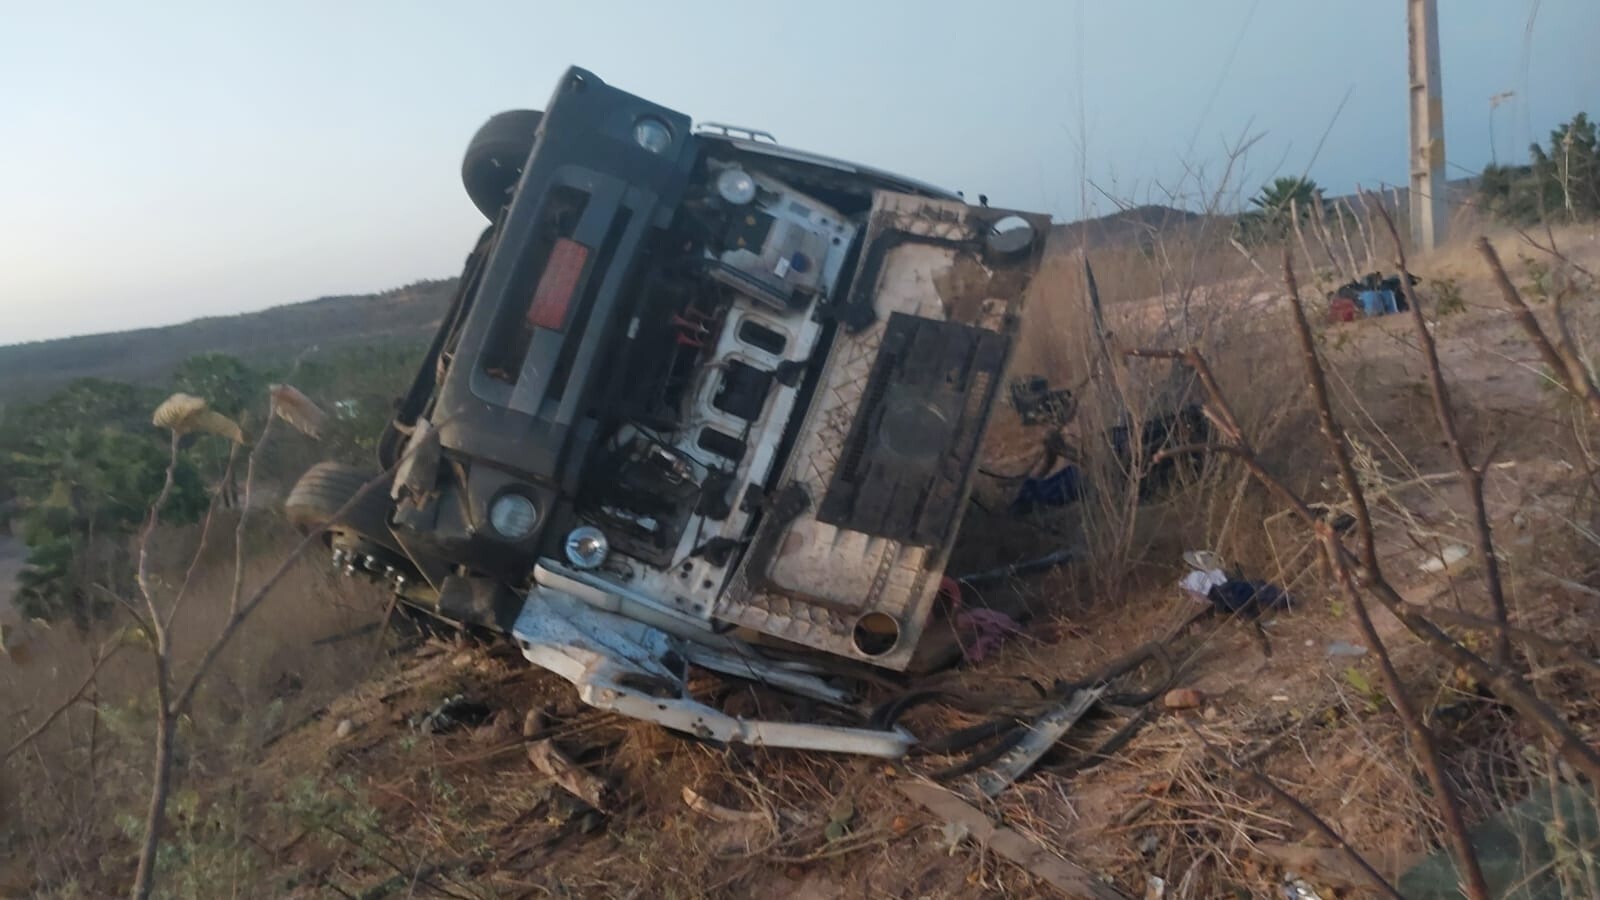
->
[0, 279, 456, 400]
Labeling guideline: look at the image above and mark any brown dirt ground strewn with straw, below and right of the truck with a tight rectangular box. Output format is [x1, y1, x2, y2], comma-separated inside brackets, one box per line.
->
[9, 220, 1600, 898]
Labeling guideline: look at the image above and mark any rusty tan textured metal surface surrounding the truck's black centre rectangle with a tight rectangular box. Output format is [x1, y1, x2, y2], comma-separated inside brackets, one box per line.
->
[715, 194, 1050, 669]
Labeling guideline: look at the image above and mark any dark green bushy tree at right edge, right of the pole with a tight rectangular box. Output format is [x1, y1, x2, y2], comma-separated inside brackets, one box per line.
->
[1478, 112, 1600, 224]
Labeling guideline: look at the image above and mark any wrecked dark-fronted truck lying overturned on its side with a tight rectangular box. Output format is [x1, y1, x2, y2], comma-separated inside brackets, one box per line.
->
[286, 69, 1048, 756]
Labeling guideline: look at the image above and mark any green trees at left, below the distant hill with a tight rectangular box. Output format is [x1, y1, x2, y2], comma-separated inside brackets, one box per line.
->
[0, 341, 421, 628]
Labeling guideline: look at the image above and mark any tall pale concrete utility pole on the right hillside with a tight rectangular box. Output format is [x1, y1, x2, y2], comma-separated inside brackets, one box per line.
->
[1406, 0, 1450, 253]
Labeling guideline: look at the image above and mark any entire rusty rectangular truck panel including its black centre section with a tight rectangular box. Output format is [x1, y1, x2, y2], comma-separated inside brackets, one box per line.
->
[715, 194, 1050, 669]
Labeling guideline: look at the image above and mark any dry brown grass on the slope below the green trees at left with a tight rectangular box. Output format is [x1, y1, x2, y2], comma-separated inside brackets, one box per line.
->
[0, 512, 384, 894]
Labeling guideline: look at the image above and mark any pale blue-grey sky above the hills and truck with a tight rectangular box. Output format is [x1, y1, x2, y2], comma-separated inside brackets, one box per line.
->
[0, 0, 1600, 344]
